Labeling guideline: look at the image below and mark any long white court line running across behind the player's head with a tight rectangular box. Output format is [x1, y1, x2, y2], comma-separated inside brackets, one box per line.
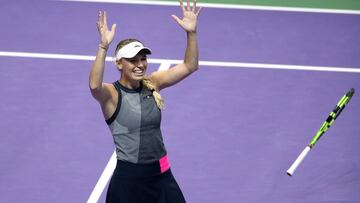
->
[0, 51, 360, 73]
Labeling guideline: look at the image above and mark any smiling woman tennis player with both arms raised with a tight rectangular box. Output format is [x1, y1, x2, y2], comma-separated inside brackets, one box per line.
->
[89, 0, 201, 203]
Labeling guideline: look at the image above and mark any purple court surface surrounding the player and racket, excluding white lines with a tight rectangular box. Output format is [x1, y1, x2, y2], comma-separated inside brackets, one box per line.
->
[0, 1, 360, 203]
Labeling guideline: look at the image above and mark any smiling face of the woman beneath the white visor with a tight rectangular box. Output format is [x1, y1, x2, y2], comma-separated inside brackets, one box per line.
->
[117, 51, 148, 88]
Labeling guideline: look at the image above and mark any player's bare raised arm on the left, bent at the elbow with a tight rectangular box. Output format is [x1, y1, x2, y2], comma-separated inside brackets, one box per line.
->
[89, 11, 116, 104]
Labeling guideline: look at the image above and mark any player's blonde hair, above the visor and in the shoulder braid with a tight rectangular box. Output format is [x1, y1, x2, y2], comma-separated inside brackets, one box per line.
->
[115, 39, 165, 109]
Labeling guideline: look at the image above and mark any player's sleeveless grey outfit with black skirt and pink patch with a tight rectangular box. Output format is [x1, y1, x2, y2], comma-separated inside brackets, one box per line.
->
[106, 81, 185, 203]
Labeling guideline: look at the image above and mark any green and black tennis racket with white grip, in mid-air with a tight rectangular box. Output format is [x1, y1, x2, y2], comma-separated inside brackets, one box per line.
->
[286, 88, 355, 176]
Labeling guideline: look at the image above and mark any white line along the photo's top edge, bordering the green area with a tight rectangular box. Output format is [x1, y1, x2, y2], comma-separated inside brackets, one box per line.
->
[59, 0, 360, 15]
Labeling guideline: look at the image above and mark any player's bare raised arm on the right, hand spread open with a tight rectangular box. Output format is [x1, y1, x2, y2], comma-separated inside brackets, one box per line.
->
[150, 0, 201, 90]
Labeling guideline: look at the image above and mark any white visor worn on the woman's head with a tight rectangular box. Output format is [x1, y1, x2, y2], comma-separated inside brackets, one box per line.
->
[115, 41, 151, 60]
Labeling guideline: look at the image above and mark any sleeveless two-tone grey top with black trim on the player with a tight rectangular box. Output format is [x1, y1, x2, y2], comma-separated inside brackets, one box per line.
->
[106, 81, 166, 164]
